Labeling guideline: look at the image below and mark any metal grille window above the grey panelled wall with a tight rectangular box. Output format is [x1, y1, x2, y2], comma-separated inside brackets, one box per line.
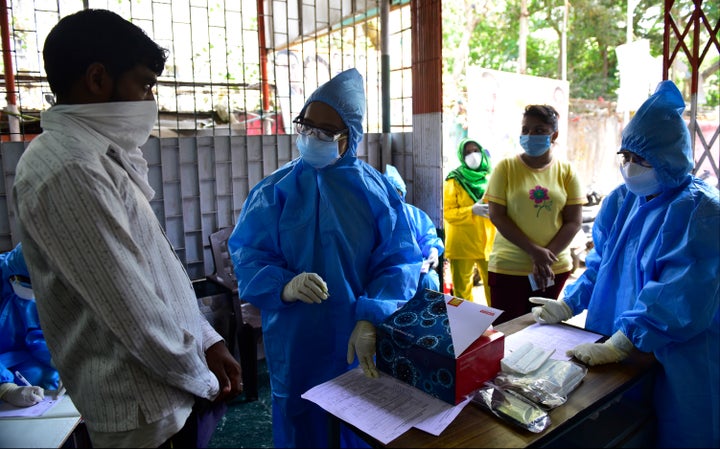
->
[1, 0, 412, 141]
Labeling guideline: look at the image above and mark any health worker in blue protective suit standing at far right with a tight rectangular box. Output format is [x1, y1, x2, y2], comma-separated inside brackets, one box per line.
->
[530, 81, 720, 447]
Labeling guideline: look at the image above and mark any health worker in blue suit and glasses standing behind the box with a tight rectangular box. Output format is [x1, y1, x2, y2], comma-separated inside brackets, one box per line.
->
[228, 69, 422, 447]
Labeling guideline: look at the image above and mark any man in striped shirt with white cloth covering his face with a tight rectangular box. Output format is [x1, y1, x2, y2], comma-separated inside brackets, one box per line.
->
[13, 10, 242, 447]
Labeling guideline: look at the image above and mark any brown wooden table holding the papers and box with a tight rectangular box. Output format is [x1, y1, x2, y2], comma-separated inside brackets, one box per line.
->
[348, 314, 659, 448]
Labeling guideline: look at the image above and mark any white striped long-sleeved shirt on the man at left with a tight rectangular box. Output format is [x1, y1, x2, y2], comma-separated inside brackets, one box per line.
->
[13, 108, 222, 436]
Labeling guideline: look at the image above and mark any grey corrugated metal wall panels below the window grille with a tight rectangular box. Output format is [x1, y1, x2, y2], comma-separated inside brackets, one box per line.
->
[0, 133, 413, 279]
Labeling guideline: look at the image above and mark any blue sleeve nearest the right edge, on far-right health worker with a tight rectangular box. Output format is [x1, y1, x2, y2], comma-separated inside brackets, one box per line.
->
[617, 186, 720, 351]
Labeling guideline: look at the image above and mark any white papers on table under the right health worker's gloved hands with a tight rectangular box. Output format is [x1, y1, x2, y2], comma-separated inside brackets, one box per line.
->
[505, 323, 603, 360]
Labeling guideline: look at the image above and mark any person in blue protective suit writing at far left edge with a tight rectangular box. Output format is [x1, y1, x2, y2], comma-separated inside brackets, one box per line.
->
[0, 243, 60, 407]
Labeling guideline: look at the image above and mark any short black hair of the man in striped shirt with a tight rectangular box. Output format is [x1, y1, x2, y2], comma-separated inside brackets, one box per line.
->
[43, 9, 168, 95]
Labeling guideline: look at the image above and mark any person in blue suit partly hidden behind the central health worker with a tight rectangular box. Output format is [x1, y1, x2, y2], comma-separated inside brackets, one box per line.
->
[385, 164, 445, 296]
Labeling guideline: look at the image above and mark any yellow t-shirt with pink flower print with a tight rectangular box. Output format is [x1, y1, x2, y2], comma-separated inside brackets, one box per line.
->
[484, 155, 586, 276]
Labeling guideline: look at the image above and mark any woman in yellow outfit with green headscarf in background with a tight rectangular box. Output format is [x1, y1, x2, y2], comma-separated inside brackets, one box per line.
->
[443, 139, 495, 304]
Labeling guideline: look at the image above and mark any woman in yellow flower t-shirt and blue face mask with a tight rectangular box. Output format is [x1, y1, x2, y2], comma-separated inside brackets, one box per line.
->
[484, 105, 585, 324]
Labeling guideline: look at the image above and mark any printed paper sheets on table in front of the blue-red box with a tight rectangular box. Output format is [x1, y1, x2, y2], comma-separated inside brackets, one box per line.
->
[302, 368, 470, 444]
